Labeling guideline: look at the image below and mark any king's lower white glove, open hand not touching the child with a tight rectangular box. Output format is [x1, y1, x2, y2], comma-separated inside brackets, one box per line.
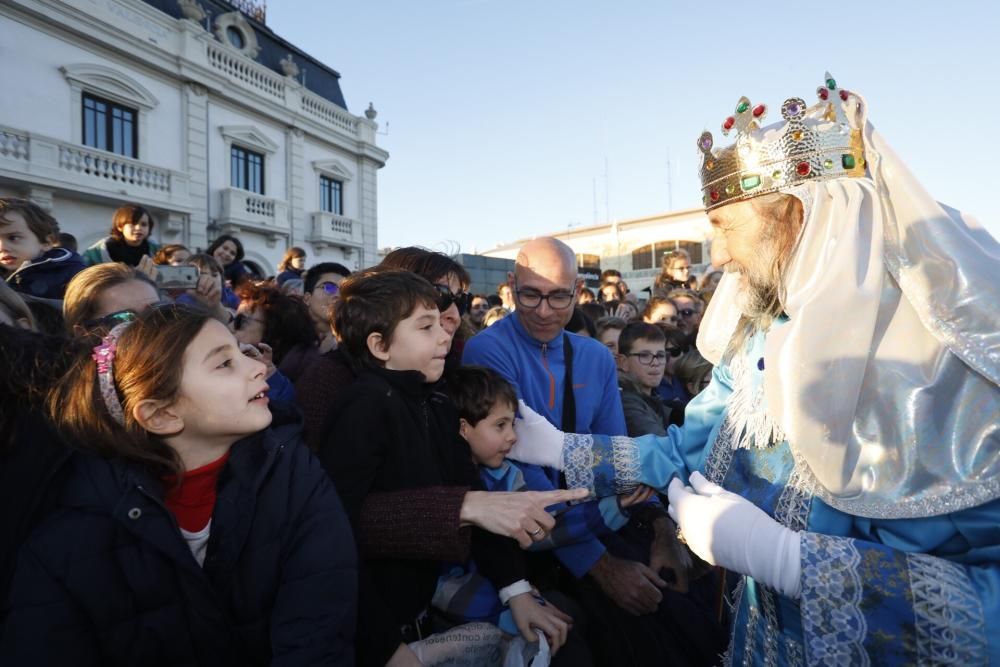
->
[667, 472, 802, 599]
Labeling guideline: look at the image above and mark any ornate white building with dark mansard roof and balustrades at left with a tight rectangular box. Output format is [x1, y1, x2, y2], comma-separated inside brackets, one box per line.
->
[0, 0, 388, 275]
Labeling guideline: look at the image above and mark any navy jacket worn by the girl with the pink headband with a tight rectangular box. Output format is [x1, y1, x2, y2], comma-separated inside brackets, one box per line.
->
[0, 414, 357, 667]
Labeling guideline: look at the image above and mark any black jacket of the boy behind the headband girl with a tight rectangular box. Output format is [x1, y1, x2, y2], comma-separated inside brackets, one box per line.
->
[318, 369, 525, 665]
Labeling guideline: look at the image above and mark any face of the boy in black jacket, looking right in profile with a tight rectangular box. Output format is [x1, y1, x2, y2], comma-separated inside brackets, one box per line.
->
[384, 304, 451, 382]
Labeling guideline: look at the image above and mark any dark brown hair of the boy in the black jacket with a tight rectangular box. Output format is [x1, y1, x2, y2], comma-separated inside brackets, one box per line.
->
[332, 268, 438, 368]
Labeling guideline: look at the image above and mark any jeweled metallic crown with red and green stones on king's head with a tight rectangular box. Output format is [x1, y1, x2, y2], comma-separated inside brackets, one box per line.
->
[698, 72, 865, 211]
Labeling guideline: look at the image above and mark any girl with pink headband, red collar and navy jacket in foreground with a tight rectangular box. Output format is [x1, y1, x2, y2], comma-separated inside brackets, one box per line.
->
[0, 305, 357, 665]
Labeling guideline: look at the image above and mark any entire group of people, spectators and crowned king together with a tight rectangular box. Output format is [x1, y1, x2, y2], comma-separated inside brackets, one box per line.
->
[0, 74, 1000, 667]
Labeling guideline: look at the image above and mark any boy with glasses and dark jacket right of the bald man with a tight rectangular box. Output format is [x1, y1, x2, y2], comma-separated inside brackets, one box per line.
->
[617, 322, 683, 438]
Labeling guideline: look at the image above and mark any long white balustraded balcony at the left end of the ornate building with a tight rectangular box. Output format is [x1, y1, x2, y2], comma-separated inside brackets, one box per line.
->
[0, 126, 188, 205]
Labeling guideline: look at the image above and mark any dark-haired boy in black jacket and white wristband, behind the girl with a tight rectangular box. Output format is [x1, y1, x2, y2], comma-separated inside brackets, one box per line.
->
[318, 270, 571, 666]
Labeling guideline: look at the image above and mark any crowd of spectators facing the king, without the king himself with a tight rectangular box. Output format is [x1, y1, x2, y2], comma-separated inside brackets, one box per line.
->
[0, 198, 724, 665]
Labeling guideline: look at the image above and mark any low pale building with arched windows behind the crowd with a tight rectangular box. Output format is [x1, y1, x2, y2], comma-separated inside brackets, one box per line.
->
[480, 208, 711, 293]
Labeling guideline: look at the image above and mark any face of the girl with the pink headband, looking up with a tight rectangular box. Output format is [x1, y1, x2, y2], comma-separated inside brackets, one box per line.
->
[172, 319, 271, 447]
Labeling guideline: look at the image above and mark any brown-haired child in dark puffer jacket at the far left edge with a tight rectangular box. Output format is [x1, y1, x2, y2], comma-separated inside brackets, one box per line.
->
[0, 197, 84, 299]
